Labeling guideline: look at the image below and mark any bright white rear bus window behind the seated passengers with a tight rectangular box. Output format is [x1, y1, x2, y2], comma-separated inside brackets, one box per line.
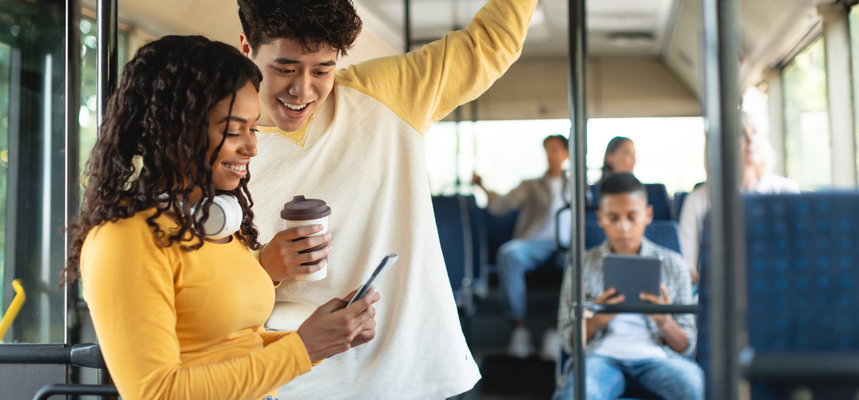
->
[425, 117, 707, 205]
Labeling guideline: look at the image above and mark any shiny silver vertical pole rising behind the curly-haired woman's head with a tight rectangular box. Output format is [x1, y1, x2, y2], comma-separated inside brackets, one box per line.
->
[96, 0, 118, 128]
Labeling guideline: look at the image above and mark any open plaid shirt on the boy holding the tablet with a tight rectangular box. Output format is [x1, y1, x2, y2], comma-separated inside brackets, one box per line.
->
[558, 238, 698, 356]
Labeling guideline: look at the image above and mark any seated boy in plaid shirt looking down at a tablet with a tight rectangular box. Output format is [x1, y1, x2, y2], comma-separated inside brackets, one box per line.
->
[555, 173, 704, 400]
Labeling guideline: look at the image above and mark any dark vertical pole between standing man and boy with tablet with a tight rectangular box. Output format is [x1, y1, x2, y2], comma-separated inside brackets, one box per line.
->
[568, 0, 587, 400]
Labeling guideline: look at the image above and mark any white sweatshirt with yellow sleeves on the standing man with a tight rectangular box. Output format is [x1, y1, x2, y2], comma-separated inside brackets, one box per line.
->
[245, 0, 537, 399]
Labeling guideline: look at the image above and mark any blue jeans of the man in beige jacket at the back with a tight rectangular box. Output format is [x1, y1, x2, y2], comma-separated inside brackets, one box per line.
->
[496, 239, 558, 320]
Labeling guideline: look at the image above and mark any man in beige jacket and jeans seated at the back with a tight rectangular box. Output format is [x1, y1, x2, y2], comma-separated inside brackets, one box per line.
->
[472, 135, 569, 360]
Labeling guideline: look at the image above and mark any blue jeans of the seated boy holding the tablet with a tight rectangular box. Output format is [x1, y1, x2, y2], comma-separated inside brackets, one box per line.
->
[552, 355, 704, 400]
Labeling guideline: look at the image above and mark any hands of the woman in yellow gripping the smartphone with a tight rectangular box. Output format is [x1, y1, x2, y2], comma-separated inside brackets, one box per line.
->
[297, 289, 381, 362]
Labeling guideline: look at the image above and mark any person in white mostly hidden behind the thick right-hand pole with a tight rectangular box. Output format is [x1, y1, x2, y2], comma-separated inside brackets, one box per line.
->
[680, 113, 799, 283]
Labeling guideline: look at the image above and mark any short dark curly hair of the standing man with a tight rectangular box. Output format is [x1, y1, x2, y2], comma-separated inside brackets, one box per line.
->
[238, 0, 361, 56]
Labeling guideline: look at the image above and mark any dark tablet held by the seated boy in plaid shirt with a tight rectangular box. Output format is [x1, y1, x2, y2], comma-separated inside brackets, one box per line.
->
[603, 254, 662, 304]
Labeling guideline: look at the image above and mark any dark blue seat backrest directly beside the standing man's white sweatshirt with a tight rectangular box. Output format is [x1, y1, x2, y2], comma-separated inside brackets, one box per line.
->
[432, 196, 473, 304]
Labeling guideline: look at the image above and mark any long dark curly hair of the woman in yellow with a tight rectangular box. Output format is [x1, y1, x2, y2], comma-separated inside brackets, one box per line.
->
[60, 36, 262, 282]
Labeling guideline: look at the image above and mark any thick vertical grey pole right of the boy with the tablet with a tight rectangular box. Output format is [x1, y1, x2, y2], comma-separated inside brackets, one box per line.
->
[702, 0, 747, 400]
